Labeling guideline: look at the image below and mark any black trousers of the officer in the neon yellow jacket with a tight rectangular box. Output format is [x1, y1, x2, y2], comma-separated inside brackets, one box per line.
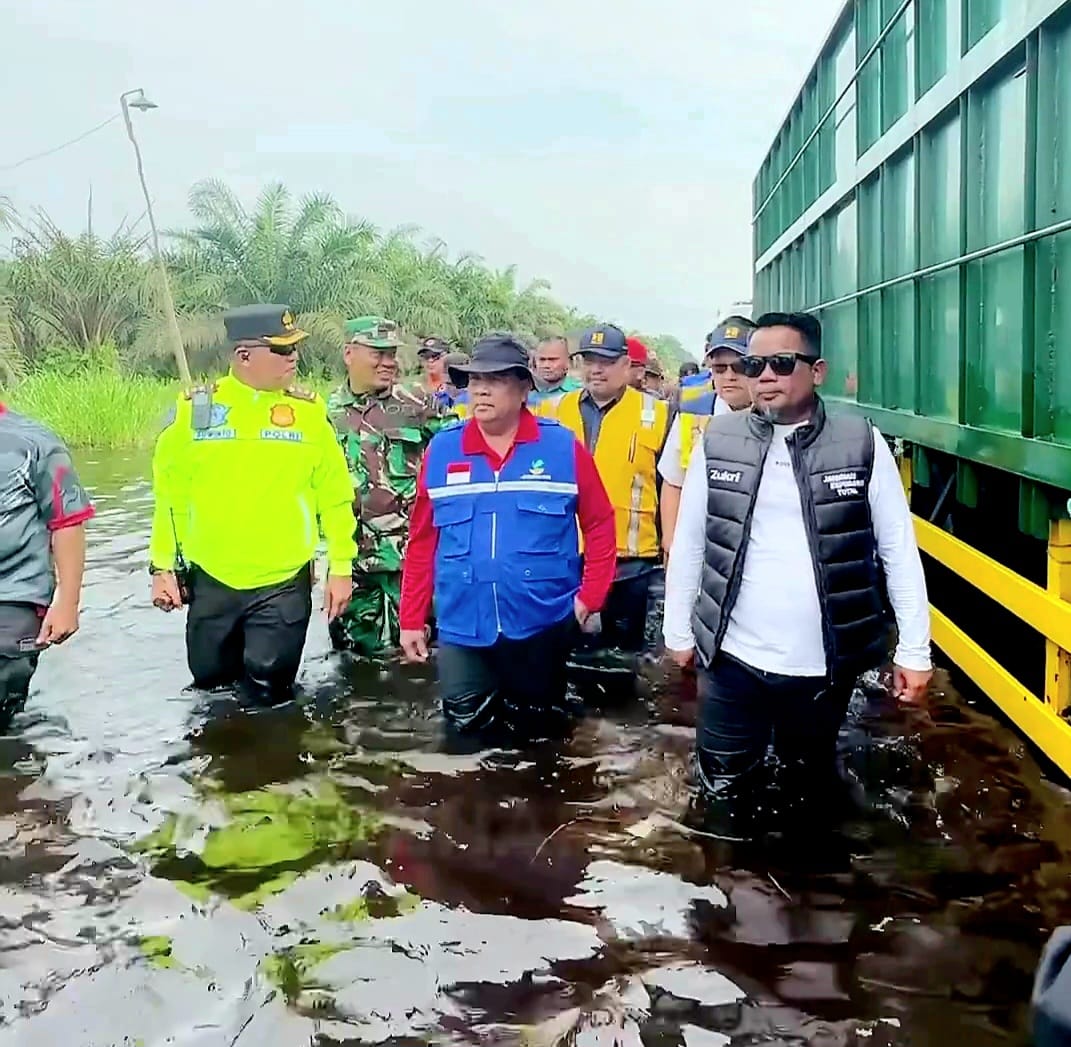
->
[186, 566, 313, 704]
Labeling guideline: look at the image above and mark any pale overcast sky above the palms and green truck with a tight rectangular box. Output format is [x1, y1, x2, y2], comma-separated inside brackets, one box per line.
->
[0, 0, 841, 350]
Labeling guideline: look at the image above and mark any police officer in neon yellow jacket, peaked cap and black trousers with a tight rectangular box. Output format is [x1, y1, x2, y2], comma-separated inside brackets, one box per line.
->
[149, 305, 357, 704]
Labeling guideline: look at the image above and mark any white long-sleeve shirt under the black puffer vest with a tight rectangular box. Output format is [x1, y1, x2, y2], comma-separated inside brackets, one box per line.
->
[662, 425, 932, 677]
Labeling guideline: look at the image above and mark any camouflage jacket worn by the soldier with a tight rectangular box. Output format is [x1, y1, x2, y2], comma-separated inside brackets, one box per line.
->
[328, 382, 454, 571]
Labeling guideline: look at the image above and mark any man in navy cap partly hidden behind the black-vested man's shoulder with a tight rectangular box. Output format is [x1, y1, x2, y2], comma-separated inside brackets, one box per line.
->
[659, 316, 754, 555]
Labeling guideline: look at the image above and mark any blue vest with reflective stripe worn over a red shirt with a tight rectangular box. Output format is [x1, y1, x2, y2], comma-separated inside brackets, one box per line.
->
[424, 419, 580, 647]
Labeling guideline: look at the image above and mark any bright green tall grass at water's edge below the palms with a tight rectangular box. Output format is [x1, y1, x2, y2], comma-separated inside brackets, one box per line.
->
[0, 369, 178, 450]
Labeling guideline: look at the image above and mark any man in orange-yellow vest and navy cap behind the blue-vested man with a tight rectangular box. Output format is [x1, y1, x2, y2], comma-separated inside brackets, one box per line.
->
[555, 323, 668, 651]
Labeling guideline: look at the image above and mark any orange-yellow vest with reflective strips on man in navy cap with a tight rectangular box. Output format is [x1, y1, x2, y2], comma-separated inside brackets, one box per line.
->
[554, 386, 669, 557]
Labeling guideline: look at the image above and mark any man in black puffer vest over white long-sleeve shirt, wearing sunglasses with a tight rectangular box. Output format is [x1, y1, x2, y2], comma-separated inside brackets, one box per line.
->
[663, 313, 931, 824]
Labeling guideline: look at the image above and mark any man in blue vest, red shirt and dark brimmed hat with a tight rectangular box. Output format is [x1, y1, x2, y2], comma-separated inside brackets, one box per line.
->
[402, 335, 614, 737]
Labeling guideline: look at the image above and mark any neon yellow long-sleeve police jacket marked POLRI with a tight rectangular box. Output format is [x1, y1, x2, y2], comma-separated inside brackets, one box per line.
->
[149, 375, 357, 589]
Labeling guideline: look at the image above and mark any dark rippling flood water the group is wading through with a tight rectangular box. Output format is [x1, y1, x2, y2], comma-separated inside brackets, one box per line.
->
[0, 454, 1071, 1047]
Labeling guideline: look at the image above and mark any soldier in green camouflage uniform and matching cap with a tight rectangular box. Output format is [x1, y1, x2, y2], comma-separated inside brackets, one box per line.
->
[328, 316, 454, 657]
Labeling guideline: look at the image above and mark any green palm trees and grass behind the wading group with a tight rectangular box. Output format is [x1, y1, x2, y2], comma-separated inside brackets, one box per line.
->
[0, 181, 684, 446]
